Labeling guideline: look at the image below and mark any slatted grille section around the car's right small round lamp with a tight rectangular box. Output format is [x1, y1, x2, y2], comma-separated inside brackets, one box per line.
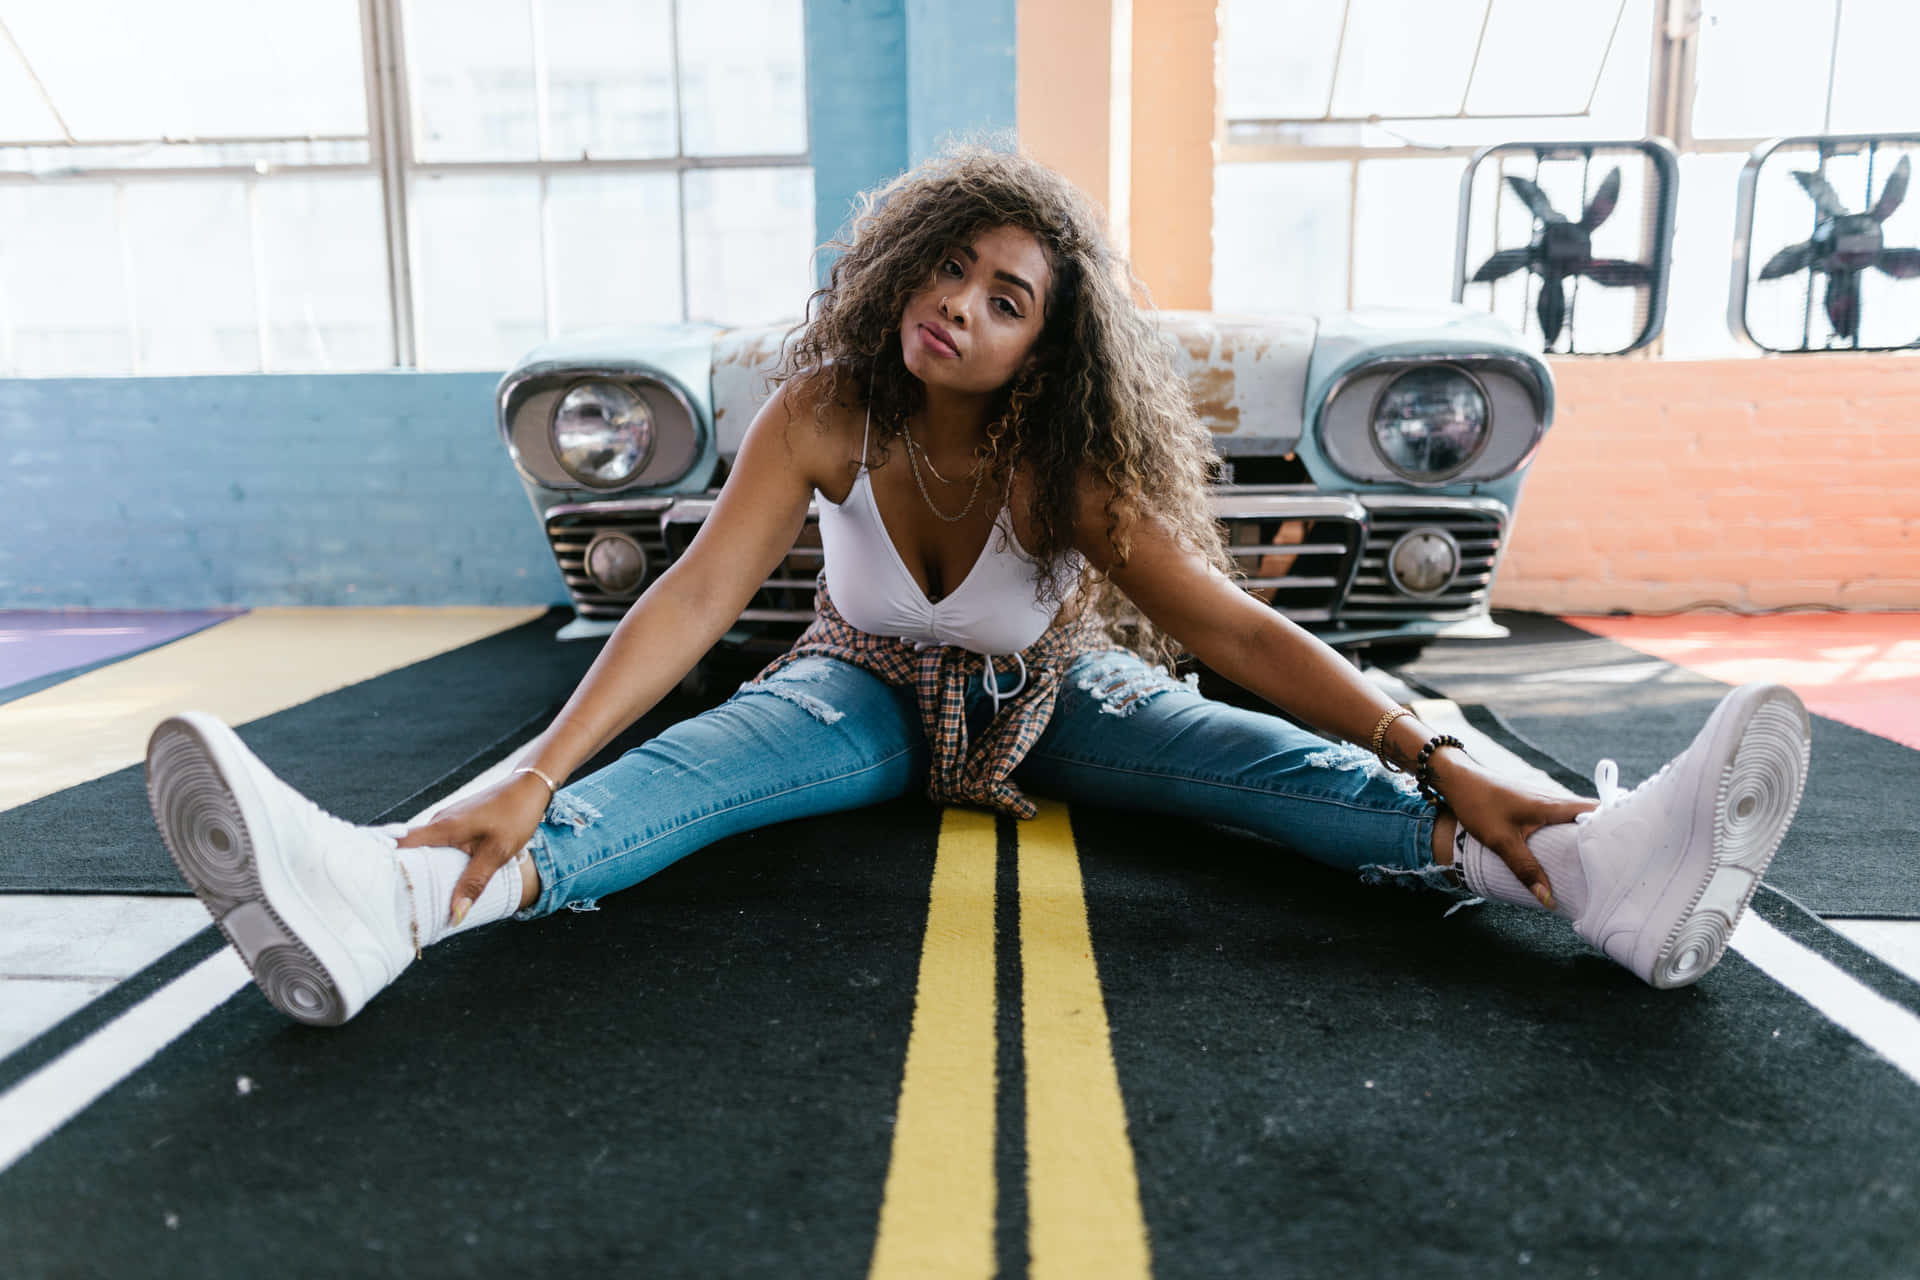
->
[1340, 497, 1507, 628]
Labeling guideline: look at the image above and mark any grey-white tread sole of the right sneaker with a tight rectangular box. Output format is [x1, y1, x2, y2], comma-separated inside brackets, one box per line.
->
[1647, 689, 1812, 988]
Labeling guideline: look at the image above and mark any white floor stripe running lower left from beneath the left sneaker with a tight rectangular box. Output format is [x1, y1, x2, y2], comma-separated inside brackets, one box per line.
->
[0, 948, 250, 1173]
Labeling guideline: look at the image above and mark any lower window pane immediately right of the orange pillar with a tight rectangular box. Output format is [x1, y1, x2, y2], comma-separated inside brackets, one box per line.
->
[1213, 163, 1350, 313]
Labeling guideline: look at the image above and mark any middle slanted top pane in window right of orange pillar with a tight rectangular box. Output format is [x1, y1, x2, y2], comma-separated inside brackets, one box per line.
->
[1332, 0, 1486, 115]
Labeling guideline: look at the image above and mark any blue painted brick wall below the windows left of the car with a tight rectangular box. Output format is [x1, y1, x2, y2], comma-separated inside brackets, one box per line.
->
[0, 372, 566, 608]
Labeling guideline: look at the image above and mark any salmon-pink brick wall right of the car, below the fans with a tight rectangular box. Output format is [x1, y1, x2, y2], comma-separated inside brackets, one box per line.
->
[1494, 355, 1920, 614]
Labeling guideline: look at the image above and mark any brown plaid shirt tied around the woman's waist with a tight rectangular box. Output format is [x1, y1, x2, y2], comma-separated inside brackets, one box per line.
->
[747, 570, 1114, 818]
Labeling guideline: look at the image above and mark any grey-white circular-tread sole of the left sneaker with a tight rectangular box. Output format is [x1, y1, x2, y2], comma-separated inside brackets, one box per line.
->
[146, 718, 351, 1027]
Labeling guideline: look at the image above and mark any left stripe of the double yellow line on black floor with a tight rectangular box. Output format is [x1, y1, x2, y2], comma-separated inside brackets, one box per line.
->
[870, 808, 996, 1280]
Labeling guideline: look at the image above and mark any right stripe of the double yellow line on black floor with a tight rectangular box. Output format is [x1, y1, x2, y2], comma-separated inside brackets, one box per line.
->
[1020, 800, 1152, 1280]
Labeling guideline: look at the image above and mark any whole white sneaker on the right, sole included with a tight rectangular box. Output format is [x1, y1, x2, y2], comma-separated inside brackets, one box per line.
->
[1574, 685, 1811, 986]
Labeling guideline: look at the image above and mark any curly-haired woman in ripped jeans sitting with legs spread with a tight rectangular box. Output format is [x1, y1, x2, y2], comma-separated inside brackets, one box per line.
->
[148, 148, 1807, 1025]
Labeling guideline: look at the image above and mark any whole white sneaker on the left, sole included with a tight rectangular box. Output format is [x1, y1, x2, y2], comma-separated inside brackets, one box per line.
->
[146, 712, 419, 1027]
